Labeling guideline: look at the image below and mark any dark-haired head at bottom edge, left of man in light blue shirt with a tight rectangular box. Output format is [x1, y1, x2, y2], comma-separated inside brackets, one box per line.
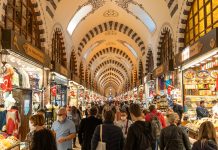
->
[30, 129, 57, 150]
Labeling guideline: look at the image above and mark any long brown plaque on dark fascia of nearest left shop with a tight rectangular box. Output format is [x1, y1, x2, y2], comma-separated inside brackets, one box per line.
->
[23, 43, 45, 64]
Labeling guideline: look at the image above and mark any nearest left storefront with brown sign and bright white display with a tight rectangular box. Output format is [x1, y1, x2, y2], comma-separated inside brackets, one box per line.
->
[0, 30, 50, 140]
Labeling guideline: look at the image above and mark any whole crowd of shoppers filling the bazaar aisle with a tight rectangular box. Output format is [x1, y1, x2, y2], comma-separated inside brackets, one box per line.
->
[26, 101, 218, 150]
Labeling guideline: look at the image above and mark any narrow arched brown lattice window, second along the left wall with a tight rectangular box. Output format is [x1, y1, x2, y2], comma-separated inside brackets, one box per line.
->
[52, 28, 66, 67]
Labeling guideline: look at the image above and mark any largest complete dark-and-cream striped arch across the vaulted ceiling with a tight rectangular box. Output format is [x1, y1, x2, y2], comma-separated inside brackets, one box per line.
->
[78, 21, 145, 56]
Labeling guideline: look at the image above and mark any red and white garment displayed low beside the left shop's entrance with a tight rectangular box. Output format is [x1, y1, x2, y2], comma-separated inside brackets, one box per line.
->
[6, 109, 21, 138]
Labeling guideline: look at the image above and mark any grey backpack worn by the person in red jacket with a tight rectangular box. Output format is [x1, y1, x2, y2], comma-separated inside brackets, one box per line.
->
[150, 114, 162, 139]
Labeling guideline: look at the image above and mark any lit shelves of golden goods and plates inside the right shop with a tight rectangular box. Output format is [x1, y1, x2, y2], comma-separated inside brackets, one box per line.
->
[183, 56, 218, 117]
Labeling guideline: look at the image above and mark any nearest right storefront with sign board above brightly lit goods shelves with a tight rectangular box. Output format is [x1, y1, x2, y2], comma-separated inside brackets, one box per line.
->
[177, 29, 218, 120]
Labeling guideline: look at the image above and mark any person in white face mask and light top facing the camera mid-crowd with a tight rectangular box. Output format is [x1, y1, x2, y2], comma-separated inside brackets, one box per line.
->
[115, 107, 132, 139]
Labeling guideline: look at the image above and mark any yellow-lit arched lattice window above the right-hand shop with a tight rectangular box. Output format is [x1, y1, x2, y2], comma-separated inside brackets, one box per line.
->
[185, 0, 218, 46]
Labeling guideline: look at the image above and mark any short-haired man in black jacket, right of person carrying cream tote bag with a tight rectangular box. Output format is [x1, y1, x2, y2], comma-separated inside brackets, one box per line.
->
[124, 104, 152, 150]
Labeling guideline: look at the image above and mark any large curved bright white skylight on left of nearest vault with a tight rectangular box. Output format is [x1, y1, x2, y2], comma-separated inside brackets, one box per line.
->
[67, 4, 93, 35]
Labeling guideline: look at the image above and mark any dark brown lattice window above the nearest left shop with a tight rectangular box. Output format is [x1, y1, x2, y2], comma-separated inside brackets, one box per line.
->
[4, 0, 41, 49]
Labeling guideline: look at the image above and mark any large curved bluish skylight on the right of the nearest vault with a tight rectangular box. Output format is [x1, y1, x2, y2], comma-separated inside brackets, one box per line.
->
[128, 3, 156, 32]
